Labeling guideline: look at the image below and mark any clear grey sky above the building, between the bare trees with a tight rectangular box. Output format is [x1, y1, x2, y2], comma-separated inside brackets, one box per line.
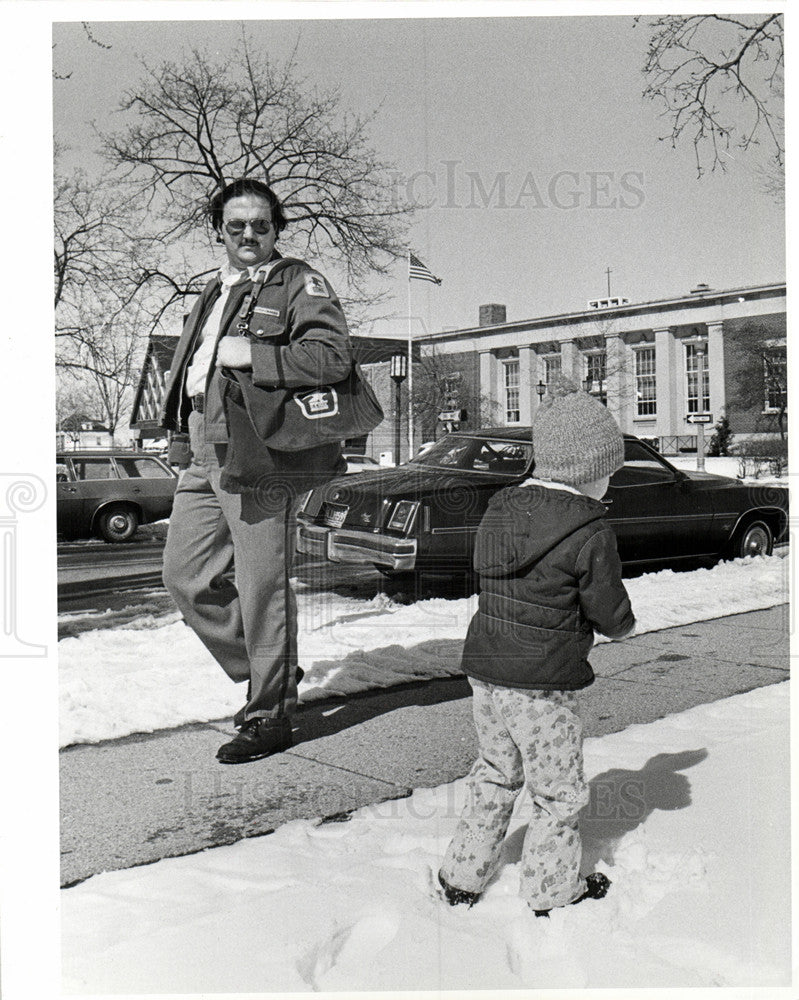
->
[53, 12, 785, 336]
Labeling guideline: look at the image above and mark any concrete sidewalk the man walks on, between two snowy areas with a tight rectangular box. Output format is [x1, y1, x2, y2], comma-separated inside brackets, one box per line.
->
[61, 605, 790, 885]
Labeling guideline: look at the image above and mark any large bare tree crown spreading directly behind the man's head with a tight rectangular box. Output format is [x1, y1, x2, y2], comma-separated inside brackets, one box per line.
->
[103, 33, 410, 293]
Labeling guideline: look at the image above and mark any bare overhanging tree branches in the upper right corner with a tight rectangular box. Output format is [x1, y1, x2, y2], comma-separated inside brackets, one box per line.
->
[636, 13, 785, 189]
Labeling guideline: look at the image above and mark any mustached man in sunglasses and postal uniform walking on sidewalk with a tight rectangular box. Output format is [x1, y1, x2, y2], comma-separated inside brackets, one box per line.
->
[161, 178, 353, 764]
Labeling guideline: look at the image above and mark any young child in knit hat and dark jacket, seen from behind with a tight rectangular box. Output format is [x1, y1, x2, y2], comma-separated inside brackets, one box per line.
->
[438, 377, 635, 916]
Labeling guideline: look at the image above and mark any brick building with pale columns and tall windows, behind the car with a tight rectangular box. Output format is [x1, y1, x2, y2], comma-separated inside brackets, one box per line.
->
[419, 283, 787, 453]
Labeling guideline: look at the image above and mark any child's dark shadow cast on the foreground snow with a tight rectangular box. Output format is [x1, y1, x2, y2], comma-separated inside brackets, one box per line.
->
[505, 750, 707, 872]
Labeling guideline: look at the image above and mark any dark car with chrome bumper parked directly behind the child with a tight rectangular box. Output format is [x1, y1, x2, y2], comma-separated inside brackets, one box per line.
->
[297, 427, 788, 574]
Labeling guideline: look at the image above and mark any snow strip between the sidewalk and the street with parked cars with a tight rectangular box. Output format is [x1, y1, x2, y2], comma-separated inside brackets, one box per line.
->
[59, 556, 789, 746]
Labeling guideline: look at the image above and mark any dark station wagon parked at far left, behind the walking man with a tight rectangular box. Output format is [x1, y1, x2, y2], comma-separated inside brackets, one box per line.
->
[56, 450, 178, 542]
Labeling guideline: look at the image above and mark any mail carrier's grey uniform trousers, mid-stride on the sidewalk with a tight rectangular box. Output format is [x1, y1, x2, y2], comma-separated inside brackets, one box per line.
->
[164, 413, 297, 726]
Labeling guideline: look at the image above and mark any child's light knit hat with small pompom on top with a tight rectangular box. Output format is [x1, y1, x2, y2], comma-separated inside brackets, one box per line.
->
[533, 375, 624, 485]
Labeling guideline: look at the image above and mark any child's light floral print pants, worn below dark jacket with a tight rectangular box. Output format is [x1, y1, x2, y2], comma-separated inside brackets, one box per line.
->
[441, 678, 588, 910]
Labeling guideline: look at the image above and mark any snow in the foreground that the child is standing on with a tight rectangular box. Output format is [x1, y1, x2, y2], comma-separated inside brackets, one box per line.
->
[61, 684, 791, 995]
